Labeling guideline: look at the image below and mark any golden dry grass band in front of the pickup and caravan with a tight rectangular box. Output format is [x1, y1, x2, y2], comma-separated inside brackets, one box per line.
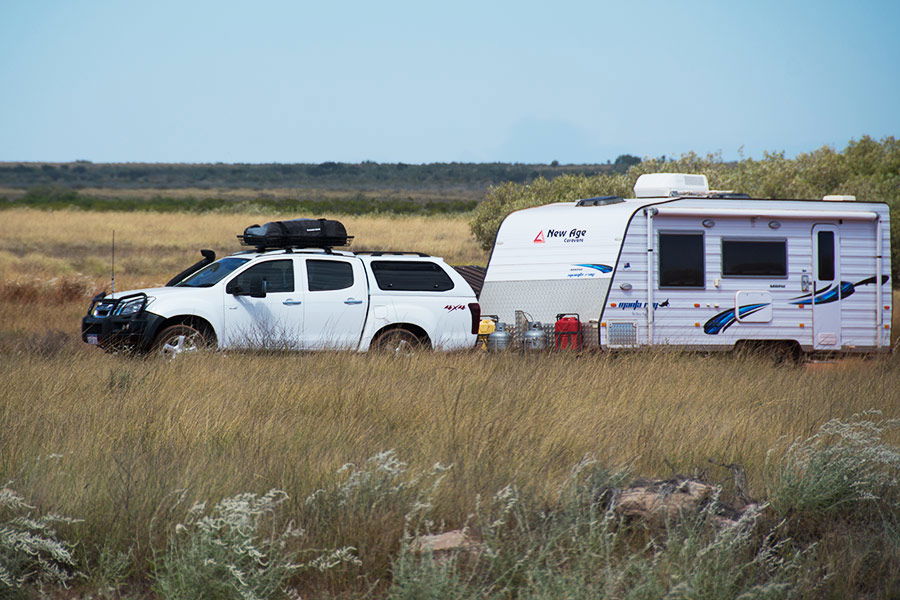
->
[0, 341, 900, 590]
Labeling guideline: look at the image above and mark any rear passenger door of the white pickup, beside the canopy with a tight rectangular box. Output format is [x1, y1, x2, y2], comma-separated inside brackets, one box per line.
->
[303, 256, 369, 350]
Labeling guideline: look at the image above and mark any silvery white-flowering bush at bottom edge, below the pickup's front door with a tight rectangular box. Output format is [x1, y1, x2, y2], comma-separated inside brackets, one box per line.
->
[155, 490, 356, 600]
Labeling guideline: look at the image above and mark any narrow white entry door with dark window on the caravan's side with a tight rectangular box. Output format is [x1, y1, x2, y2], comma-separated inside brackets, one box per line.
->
[812, 225, 841, 350]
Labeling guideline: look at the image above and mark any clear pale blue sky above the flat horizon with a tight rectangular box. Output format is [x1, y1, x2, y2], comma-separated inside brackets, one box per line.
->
[0, 0, 900, 163]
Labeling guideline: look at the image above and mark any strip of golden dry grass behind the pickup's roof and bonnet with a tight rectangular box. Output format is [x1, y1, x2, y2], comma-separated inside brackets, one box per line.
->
[0, 209, 486, 287]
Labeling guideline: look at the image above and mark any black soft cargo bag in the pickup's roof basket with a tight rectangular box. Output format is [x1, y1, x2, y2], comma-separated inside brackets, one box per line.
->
[238, 219, 353, 250]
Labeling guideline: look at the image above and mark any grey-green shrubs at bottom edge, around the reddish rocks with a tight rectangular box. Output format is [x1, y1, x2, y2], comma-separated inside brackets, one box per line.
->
[389, 464, 814, 600]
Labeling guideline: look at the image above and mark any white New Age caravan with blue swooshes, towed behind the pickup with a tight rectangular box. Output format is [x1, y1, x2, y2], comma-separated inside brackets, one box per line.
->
[480, 173, 891, 352]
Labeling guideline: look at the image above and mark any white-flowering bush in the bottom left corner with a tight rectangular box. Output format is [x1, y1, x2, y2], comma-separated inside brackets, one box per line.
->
[0, 485, 77, 598]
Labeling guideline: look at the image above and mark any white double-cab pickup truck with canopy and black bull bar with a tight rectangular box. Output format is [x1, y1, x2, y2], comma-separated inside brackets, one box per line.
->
[82, 248, 480, 355]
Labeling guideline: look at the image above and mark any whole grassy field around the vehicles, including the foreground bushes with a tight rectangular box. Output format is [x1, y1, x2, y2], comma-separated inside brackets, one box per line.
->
[0, 209, 900, 600]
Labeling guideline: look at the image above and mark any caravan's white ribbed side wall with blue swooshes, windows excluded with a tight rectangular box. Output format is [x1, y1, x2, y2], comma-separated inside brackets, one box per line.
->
[600, 200, 891, 351]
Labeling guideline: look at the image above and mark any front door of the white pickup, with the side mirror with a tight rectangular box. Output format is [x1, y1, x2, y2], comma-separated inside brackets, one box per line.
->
[223, 258, 303, 350]
